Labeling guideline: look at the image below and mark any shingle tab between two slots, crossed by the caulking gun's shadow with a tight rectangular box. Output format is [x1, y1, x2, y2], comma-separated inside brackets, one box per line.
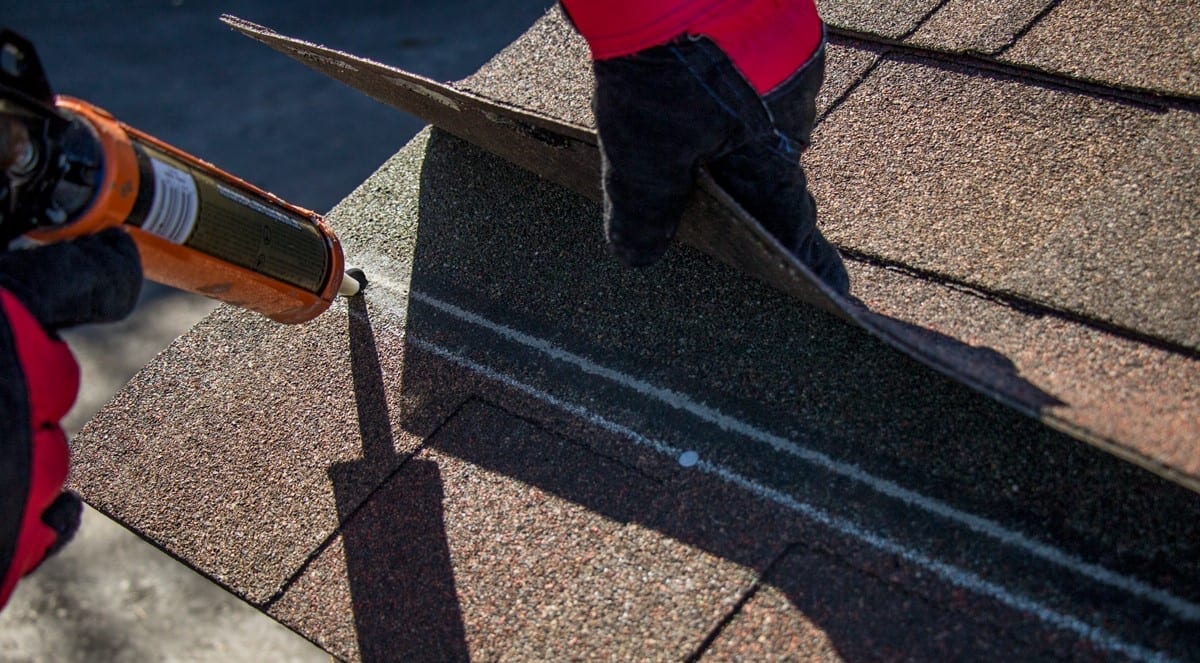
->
[271, 401, 752, 661]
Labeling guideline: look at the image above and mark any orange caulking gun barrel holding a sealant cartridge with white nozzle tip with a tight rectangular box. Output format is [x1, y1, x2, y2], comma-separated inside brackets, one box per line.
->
[28, 96, 355, 323]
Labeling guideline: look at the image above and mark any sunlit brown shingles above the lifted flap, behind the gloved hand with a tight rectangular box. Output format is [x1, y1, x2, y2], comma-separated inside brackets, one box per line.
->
[446, 9, 1200, 488]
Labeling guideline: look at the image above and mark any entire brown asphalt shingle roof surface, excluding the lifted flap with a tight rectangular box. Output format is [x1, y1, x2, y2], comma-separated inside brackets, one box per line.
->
[72, 0, 1200, 659]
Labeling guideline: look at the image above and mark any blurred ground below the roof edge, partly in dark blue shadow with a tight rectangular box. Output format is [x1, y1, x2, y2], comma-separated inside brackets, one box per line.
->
[0, 0, 550, 661]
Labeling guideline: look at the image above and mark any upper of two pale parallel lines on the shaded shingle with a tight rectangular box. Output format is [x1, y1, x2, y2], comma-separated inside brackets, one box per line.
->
[409, 291, 1200, 621]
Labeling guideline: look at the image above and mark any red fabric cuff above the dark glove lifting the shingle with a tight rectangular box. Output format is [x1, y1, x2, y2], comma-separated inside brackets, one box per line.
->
[562, 0, 824, 94]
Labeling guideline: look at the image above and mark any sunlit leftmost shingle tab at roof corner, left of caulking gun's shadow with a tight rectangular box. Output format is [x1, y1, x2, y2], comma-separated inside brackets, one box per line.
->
[71, 302, 441, 602]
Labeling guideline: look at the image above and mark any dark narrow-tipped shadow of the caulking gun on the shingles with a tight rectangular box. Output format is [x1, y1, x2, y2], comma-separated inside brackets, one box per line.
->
[329, 297, 468, 662]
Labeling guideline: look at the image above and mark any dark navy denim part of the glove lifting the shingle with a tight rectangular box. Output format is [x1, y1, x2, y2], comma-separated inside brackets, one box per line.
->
[593, 36, 850, 294]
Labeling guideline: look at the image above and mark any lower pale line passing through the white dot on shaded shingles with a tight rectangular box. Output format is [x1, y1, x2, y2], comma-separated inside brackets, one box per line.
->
[408, 335, 1174, 662]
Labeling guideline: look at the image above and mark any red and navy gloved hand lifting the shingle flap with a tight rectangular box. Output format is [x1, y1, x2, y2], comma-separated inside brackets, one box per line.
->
[563, 0, 850, 294]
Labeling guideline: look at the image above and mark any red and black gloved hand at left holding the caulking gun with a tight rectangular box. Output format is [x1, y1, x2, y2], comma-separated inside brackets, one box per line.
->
[0, 228, 142, 608]
